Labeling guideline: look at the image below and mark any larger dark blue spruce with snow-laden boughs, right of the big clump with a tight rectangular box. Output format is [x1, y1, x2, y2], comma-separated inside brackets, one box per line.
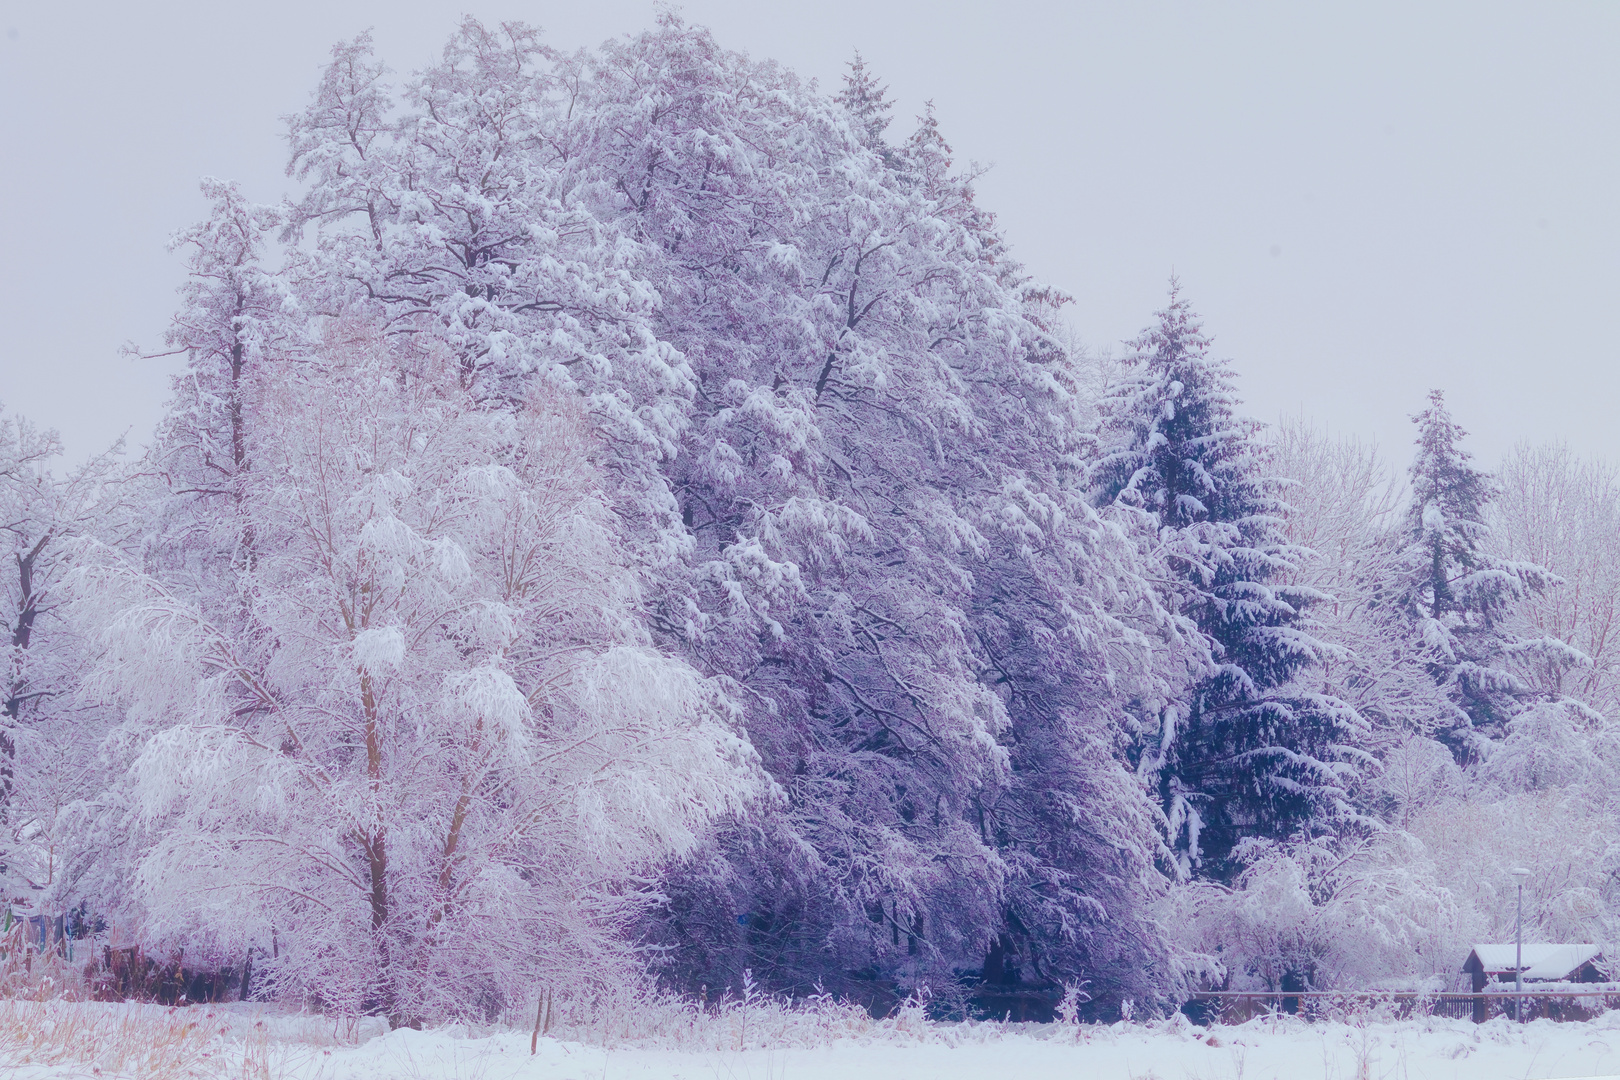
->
[1092, 280, 1364, 878]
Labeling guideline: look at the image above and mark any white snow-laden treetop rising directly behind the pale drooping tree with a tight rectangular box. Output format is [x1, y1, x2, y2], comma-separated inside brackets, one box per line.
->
[284, 18, 692, 563]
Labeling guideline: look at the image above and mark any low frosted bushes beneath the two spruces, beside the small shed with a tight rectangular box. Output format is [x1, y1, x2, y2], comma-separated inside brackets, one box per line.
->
[1165, 703, 1620, 989]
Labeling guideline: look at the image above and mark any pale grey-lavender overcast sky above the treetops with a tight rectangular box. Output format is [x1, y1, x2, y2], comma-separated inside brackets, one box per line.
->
[0, 0, 1620, 463]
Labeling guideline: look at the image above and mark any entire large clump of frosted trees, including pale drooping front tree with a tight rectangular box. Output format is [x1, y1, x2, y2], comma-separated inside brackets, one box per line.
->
[0, 15, 1192, 1018]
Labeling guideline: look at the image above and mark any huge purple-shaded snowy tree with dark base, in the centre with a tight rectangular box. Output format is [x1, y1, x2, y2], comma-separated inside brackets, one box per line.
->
[573, 18, 1173, 989]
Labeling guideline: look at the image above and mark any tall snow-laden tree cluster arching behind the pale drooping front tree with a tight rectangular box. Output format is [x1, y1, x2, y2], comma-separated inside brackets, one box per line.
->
[94, 15, 1184, 1016]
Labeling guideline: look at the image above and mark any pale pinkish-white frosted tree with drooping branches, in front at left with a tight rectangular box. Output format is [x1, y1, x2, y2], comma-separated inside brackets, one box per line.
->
[75, 316, 757, 1022]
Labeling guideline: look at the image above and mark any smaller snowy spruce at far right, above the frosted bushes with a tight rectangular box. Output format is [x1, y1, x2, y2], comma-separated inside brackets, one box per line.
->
[1392, 390, 1586, 763]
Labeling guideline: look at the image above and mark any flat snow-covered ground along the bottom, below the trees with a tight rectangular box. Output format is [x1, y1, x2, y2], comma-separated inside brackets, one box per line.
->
[9, 1006, 1620, 1080]
